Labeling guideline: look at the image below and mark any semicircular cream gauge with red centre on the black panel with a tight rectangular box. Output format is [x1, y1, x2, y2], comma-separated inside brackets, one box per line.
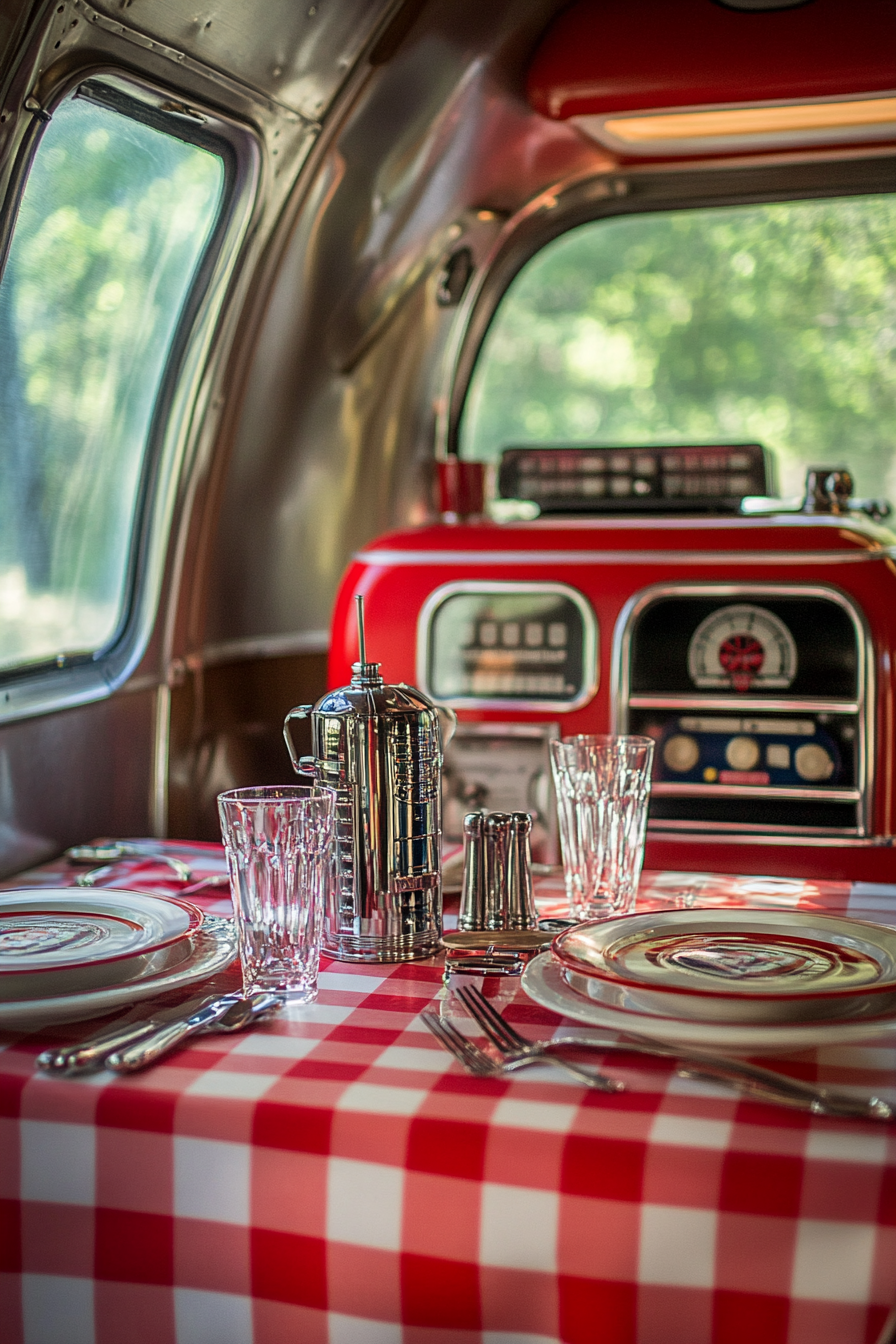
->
[688, 602, 797, 694]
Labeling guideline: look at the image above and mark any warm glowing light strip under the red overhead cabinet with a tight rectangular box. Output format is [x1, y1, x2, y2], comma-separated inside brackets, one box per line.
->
[603, 98, 896, 145]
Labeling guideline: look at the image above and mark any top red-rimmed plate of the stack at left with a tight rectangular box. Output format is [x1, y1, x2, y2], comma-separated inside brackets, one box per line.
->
[0, 887, 203, 980]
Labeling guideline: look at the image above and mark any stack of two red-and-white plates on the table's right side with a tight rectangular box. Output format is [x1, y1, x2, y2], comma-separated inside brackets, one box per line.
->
[523, 909, 896, 1051]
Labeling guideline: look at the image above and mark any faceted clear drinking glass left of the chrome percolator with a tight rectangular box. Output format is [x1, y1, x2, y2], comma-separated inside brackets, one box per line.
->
[218, 785, 336, 1003]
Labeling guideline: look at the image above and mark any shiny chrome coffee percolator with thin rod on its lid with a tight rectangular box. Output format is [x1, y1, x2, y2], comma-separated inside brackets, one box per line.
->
[283, 595, 442, 961]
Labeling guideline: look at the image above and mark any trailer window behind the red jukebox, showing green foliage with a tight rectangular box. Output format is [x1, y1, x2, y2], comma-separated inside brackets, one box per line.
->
[461, 195, 896, 508]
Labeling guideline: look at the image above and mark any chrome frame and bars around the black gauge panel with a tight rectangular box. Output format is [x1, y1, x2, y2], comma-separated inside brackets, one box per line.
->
[610, 582, 876, 843]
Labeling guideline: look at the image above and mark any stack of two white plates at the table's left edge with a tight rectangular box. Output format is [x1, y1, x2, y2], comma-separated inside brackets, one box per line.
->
[0, 887, 235, 1028]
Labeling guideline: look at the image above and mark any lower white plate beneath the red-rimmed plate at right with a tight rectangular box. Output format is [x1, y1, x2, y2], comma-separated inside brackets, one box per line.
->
[523, 952, 896, 1055]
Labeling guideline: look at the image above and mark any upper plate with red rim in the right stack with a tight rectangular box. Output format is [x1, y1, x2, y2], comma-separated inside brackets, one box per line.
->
[551, 909, 896, 1005]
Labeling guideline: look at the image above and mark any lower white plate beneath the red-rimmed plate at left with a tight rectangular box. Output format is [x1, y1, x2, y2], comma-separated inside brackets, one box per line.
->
[0, 919, 236, 1031]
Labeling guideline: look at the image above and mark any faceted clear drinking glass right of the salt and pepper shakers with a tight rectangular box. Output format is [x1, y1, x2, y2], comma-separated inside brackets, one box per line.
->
[551, 734, 653, 919]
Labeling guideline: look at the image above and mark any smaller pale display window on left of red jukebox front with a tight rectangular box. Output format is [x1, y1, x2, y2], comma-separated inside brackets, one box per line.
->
[418, 581, 598, 710]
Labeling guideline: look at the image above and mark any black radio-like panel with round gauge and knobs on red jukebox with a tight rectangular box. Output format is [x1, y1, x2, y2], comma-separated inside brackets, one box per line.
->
[619, 586, 868, 833]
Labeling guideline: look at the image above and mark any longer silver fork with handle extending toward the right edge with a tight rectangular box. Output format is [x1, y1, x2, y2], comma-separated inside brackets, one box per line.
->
[458, 985, 895, 1122]
